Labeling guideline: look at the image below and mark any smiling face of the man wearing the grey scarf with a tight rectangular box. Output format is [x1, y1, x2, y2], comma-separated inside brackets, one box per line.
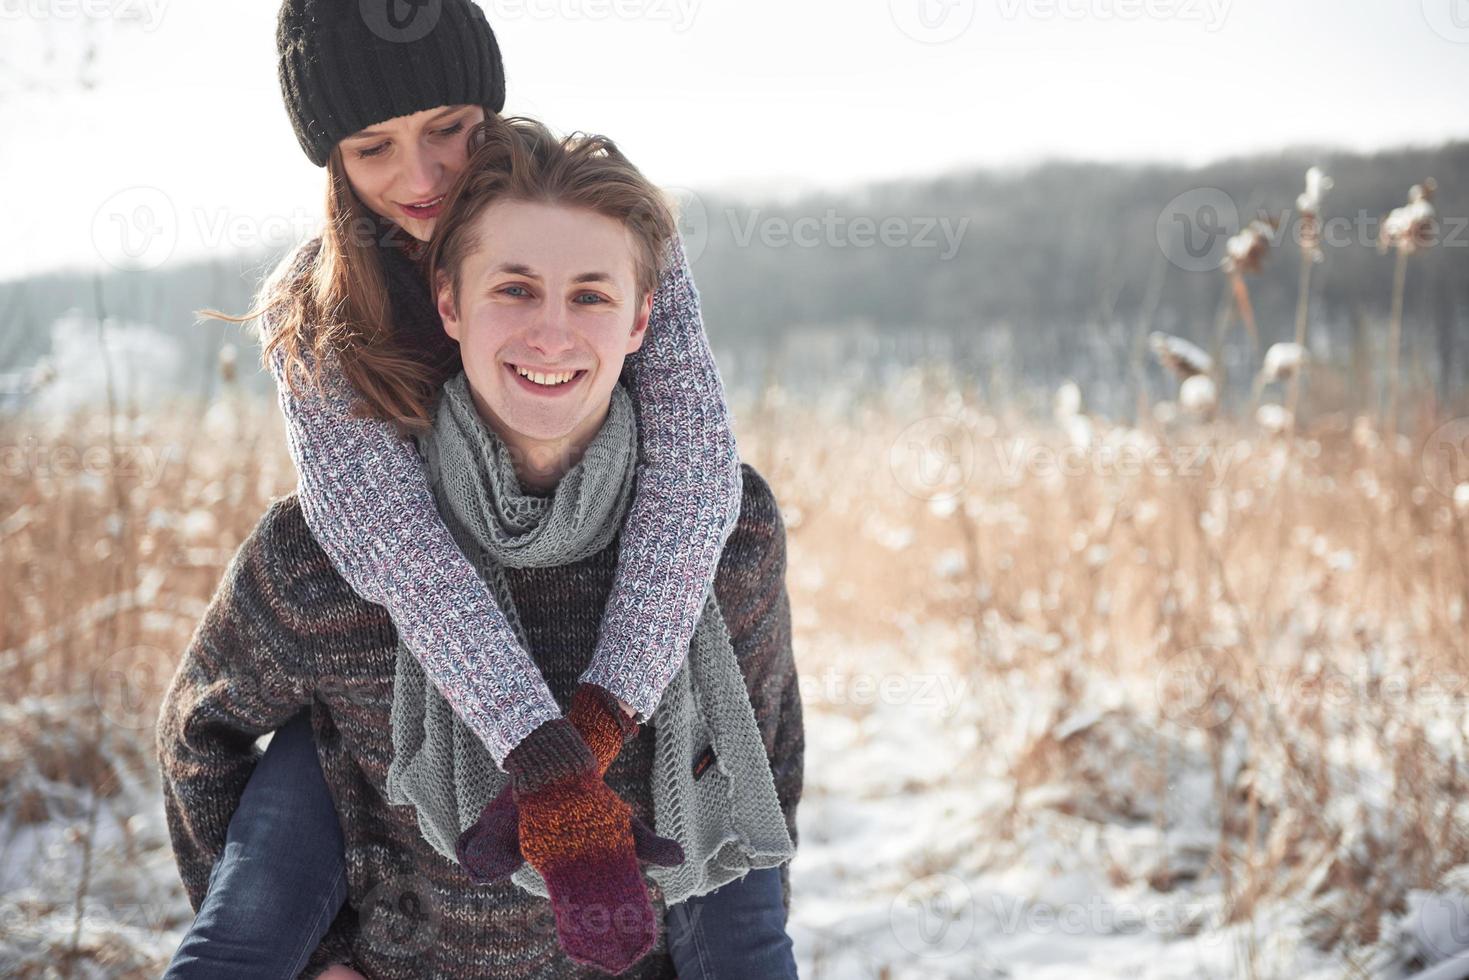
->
[439, 201, 652, 472]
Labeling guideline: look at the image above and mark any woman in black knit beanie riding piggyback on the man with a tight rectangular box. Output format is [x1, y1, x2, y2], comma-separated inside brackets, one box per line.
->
[169, 0, 793, 977]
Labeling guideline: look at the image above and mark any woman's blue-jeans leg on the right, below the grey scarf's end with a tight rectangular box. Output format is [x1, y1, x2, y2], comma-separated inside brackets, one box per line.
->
[667, 868, 796, 980]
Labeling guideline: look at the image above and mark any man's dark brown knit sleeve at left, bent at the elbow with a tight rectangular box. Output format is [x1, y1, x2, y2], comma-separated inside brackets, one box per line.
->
[154, 511, 314, 914]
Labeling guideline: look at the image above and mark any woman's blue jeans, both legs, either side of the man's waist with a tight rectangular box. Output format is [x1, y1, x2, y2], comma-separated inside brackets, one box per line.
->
[163, 708, 796, 980]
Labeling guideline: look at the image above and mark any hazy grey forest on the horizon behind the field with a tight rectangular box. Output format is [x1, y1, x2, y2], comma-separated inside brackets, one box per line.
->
[0, 143, 1469, 419]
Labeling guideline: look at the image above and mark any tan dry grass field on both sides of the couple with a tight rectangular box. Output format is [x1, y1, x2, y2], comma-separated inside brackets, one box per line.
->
[0, 362, 1469, 976]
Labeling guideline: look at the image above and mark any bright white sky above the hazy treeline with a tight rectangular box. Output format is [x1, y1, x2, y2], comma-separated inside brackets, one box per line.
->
[0, 0, 1469, 279]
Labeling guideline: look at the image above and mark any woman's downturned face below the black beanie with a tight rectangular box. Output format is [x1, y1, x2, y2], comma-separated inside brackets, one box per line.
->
[339, 106, 485, 241]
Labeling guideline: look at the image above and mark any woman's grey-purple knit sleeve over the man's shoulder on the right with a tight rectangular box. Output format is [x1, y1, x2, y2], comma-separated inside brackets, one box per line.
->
[580, 235, 740, 721]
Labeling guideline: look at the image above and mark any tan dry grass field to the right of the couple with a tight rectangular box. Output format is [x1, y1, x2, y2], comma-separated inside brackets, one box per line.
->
[742, 372, 1469, 976]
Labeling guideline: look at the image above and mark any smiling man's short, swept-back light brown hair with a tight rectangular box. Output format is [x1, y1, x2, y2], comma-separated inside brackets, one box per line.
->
[427, 116, 676, 329]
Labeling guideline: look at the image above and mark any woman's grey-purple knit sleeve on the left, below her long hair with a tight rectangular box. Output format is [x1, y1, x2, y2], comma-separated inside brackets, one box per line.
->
[270, 340, 561, 764]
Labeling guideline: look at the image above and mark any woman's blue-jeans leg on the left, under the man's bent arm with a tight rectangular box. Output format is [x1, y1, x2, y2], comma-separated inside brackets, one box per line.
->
[163, 708, 347, 980]
